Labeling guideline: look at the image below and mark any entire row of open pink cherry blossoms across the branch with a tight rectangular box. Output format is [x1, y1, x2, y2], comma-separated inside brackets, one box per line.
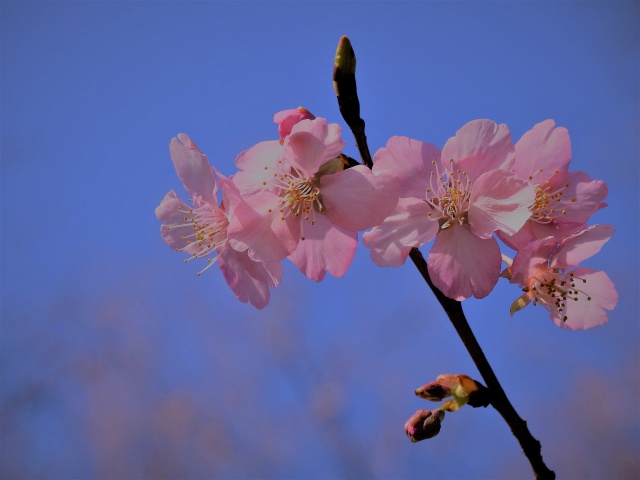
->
[156, 107, 617, 329]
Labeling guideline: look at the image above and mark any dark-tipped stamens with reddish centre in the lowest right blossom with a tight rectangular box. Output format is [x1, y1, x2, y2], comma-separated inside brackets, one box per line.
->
[523, 267, 591, 322]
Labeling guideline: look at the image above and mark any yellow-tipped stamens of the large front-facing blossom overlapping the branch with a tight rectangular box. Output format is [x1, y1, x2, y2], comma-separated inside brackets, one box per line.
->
[425, 160, 473, 230]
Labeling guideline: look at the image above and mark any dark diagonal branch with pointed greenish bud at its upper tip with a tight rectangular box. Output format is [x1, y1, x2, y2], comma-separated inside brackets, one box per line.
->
[333, 36, 556, 480]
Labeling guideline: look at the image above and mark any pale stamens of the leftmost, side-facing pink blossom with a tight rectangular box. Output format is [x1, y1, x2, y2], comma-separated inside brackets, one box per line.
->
[176, 206, 229, 276]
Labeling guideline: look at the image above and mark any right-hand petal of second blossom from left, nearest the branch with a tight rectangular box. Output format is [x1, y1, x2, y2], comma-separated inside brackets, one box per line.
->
[320, 165, 398, 231]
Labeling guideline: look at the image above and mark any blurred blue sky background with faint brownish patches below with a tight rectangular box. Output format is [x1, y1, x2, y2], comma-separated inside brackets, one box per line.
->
[0, 1, 640, 479]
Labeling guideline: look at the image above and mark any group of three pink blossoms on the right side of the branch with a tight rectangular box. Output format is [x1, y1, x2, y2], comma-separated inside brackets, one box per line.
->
[363, 120, 618, 330]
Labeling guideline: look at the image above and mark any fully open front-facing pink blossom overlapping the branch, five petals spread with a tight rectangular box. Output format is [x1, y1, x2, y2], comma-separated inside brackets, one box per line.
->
[362, 120, 534, 300]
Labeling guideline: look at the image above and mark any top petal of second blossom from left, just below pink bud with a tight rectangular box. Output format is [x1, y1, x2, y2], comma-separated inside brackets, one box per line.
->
[284, 118, 345, 177]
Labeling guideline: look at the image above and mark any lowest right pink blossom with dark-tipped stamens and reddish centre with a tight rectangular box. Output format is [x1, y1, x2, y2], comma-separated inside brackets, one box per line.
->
[503, 225, 618, 330]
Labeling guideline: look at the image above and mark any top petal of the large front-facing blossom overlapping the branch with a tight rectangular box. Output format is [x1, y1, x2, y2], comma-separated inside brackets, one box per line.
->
[441, 120, 515, 180]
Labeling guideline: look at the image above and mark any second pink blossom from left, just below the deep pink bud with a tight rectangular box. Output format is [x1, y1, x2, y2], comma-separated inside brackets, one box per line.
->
[228, 118, 398, 281]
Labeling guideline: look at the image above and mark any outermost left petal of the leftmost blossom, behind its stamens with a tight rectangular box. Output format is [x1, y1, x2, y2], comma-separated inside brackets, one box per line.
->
[156, 190, 200, 254]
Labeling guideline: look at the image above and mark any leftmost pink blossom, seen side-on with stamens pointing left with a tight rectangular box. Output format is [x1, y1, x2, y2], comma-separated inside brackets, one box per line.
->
[156, 133, 282, 309]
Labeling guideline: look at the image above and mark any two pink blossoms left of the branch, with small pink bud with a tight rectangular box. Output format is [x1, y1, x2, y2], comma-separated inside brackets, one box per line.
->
[156, 108, 398, 308]
